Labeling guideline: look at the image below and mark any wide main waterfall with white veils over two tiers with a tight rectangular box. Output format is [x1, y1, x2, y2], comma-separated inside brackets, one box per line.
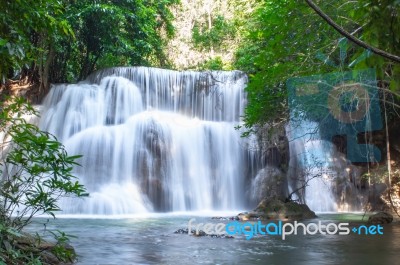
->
[40, 67, 257, 215]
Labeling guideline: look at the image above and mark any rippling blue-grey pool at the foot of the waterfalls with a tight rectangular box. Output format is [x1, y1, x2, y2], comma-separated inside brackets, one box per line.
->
[26, 214, 400, 265]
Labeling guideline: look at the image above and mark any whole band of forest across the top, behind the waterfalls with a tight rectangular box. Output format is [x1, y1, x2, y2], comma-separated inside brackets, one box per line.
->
[0, 0, 400, 127]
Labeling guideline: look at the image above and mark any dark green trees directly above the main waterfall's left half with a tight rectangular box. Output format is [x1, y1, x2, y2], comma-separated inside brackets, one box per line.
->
[53, 0, 177, 81]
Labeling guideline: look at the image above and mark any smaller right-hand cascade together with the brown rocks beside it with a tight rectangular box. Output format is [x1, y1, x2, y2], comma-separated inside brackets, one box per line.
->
[287, 120, 366, 212]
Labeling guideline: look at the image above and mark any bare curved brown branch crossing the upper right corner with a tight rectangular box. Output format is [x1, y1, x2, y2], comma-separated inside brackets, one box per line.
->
[306, 0, 400, 63]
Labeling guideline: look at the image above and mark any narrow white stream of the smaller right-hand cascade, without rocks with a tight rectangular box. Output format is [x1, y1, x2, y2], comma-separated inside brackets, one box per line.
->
[288, 120, 337, 212]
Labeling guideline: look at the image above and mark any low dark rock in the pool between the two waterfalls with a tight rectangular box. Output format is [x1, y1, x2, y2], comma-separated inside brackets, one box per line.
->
[238, 198, 317, 221]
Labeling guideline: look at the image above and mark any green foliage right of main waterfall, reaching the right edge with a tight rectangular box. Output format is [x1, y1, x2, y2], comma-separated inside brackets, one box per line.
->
[235, 0, 400, 132]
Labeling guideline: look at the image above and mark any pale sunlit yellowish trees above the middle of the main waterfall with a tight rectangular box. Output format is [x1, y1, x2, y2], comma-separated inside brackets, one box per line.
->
[166, 0, 248, 70]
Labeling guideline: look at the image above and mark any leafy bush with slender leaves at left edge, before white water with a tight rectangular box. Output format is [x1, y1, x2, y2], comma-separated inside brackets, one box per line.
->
[0, 99, 87, 230]
